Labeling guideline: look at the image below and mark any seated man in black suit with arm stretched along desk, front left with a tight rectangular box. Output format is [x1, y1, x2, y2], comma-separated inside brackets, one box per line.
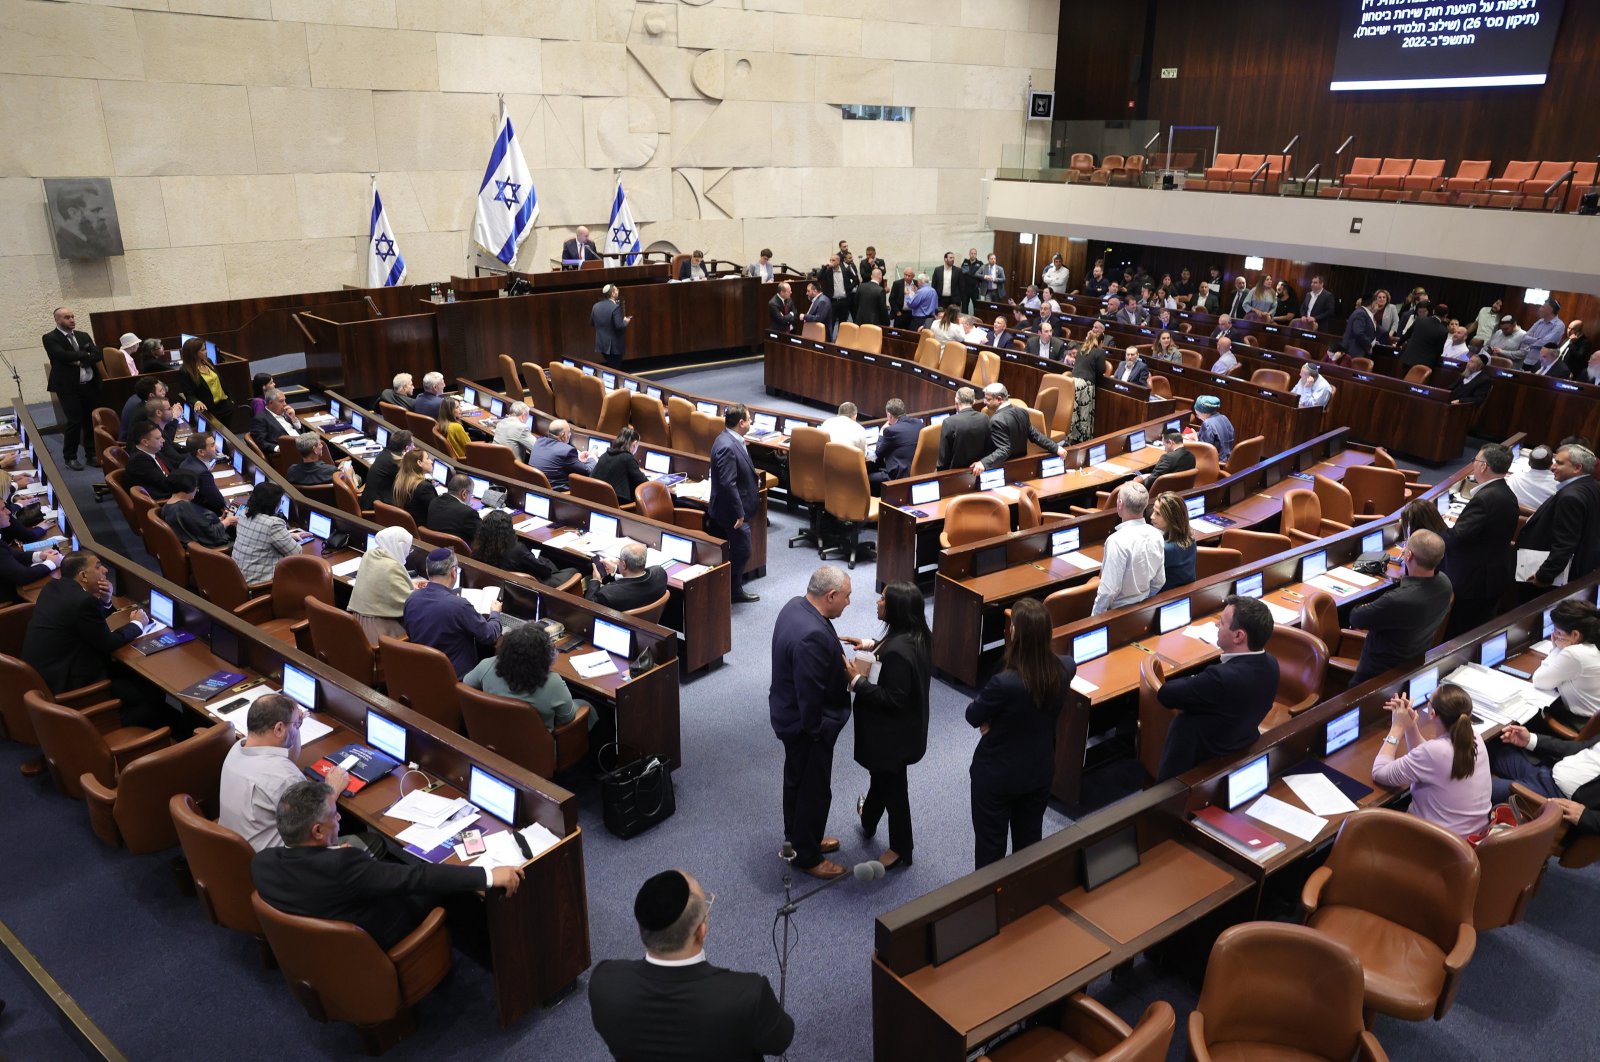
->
[250, 781, 522, 950]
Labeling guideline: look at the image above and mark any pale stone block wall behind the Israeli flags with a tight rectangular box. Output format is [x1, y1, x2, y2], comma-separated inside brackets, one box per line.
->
[0, 0, 1059, 400]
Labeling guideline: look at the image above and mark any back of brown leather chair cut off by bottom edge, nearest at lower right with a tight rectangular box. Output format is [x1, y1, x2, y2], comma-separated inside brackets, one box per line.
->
[1189, 921, 1389, 1062]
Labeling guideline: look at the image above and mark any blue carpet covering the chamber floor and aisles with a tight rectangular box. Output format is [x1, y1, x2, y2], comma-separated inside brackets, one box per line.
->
[0, 363, 1600, 1062]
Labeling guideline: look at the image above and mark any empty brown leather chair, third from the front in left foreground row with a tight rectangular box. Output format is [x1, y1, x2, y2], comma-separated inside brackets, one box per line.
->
[78, 723, 235, 856]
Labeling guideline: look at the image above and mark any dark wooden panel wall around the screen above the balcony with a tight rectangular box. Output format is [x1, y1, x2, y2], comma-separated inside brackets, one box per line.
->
[1056, 0, 1600, 173]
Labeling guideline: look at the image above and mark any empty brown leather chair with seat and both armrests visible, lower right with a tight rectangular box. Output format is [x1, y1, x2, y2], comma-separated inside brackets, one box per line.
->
[1301, 808, 1478, 1022]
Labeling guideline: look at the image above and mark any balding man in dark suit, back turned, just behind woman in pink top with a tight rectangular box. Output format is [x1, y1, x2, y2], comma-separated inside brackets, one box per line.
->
[1350, 531, 1451, 686]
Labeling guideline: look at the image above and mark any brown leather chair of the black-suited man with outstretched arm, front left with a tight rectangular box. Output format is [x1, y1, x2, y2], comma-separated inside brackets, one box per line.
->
[250, 892, 451, 1054]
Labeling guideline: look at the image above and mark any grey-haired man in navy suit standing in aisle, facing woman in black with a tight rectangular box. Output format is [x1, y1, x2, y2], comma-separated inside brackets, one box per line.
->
[766, 565, 859, 878]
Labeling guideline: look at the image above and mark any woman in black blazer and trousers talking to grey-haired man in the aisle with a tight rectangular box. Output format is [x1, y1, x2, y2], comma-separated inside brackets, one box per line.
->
[856, 582, 933, 870]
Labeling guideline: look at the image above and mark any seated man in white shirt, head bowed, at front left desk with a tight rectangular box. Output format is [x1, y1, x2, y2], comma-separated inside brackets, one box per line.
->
[218, 693, 350, 852]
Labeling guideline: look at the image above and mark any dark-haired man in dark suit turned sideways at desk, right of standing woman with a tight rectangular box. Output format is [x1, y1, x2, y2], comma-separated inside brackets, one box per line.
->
[1155, 595, 1278, 782]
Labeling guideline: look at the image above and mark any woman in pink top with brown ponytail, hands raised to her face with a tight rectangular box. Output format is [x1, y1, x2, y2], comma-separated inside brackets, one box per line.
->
[1373, 683, 1491, 836]
